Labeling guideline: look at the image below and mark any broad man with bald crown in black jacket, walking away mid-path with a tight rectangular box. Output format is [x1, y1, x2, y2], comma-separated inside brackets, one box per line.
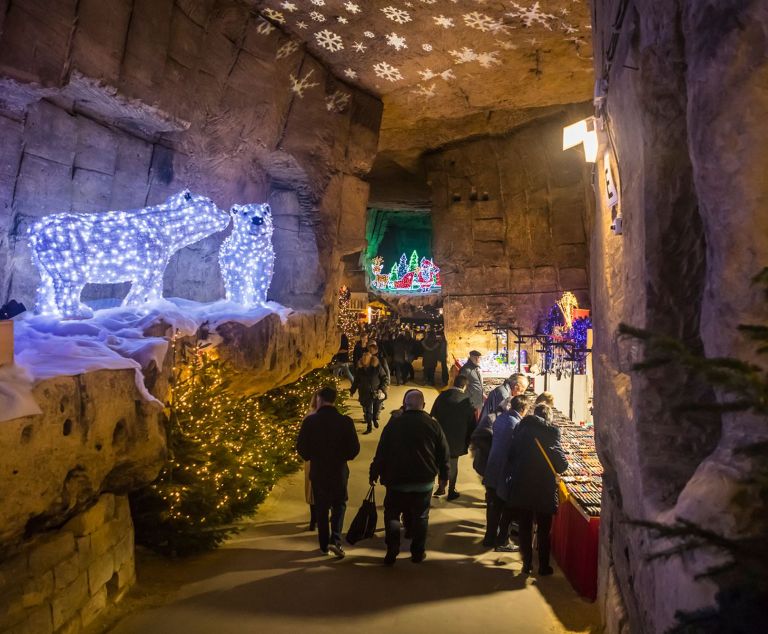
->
[370, 390, 450, 566]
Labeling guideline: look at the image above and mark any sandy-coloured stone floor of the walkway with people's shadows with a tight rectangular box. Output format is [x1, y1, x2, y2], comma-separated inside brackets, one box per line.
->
[110, 380, 600, 634]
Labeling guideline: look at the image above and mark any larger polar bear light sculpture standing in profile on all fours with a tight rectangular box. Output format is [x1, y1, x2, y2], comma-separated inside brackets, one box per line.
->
[29, 190, 230, 318]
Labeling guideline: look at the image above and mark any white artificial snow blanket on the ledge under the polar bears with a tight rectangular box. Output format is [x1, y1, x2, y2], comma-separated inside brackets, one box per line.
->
[0, 298, 293, 421]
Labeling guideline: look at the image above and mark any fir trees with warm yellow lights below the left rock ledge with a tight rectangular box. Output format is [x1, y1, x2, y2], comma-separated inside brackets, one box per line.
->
[131, 343, 343, 555]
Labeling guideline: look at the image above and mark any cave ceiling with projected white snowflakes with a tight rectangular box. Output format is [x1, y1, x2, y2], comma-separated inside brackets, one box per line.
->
[253, 0, 593, 163]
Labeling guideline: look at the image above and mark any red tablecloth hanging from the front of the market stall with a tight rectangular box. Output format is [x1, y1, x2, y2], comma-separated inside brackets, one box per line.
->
[552, 501, 600, 601]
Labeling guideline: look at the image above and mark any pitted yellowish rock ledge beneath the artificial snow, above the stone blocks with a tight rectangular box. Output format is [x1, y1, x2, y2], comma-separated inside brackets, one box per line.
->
[0, 370, 166, 554]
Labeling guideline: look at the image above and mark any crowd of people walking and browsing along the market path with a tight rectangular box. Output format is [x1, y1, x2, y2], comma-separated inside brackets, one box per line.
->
[297, 331, 568, 576]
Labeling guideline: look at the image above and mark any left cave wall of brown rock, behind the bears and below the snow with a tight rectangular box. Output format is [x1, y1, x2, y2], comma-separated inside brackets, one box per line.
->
[0, 0, 382, 632]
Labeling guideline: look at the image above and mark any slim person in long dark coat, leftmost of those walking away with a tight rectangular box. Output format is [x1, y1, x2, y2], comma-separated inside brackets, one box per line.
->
[296, 387, 360, 559]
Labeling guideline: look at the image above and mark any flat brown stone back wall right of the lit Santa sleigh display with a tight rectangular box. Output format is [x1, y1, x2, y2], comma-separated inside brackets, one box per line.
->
[426, 106, 590, 358]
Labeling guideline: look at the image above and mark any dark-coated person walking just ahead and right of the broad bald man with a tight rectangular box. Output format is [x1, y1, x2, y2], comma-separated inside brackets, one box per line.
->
[430, 375, 475, 500]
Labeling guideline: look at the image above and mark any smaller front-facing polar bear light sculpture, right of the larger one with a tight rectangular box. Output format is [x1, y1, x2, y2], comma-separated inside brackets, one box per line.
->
[219, 203, 275, 306]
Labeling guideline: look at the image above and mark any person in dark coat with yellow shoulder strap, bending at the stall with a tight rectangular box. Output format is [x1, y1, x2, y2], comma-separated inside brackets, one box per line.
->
[507, 403, 568, 575]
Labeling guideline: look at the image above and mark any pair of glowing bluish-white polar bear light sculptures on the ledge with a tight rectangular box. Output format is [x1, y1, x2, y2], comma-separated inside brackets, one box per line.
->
[29, 190, 275, 318]
